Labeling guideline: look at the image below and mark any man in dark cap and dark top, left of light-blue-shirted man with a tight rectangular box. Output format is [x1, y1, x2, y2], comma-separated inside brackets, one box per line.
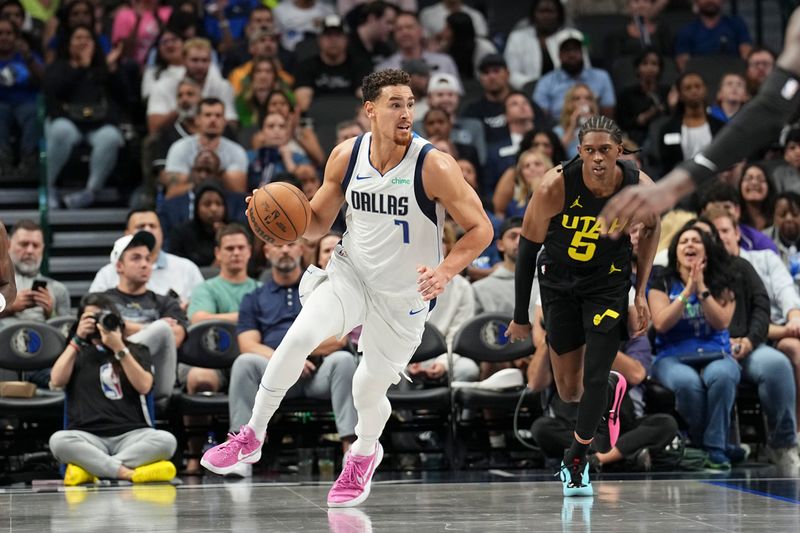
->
[461, 54, 552, 144]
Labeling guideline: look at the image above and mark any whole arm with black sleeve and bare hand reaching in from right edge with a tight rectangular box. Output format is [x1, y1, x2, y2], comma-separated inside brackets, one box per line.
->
[601, 7, 800, 224]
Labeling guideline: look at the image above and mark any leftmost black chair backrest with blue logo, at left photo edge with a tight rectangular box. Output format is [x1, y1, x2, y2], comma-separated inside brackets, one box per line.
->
[0, 320, 67, 371]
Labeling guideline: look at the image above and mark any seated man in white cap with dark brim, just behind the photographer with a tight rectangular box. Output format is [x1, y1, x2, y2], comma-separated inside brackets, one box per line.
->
[105, 231, 189, 401]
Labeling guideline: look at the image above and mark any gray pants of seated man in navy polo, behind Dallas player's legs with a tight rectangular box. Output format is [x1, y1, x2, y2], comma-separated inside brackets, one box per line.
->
[228, 351, 358, 437]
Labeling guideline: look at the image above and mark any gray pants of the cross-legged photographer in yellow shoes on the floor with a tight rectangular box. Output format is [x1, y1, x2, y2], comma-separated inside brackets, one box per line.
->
[50, 428, 178, 479]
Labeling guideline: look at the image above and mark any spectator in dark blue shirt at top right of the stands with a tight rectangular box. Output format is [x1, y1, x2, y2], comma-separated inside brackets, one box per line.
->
[675, 0, 753, 70]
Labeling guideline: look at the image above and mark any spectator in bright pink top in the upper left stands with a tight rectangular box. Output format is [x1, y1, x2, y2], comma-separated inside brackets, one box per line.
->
[111, 0, 172, 68]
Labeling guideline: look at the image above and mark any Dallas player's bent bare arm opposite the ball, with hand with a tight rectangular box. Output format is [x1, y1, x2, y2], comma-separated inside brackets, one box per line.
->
[418, 150, 494, 300]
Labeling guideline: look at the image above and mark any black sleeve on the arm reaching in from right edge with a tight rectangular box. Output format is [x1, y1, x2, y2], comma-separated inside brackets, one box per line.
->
[679, 67, 800, 187]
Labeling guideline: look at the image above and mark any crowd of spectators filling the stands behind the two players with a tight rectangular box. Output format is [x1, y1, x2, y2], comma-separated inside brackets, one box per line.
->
[0, 0, 800, 480]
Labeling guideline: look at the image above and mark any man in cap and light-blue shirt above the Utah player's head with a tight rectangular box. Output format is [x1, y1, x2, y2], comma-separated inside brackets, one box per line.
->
[533, 29, 617, 120]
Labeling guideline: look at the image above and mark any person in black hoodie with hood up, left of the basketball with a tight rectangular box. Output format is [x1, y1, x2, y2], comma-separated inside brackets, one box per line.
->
[167, 181, 228, 267]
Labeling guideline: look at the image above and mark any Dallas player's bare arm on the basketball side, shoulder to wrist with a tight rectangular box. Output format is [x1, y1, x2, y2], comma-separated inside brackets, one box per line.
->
[303, 139, 355, 239]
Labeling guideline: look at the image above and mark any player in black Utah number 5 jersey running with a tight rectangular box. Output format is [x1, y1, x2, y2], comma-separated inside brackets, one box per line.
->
[507, 116, 660, 496]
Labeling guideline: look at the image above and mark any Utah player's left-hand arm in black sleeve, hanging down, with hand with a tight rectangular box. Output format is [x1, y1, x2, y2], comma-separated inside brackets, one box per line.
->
[506, 165, 564, 342]
